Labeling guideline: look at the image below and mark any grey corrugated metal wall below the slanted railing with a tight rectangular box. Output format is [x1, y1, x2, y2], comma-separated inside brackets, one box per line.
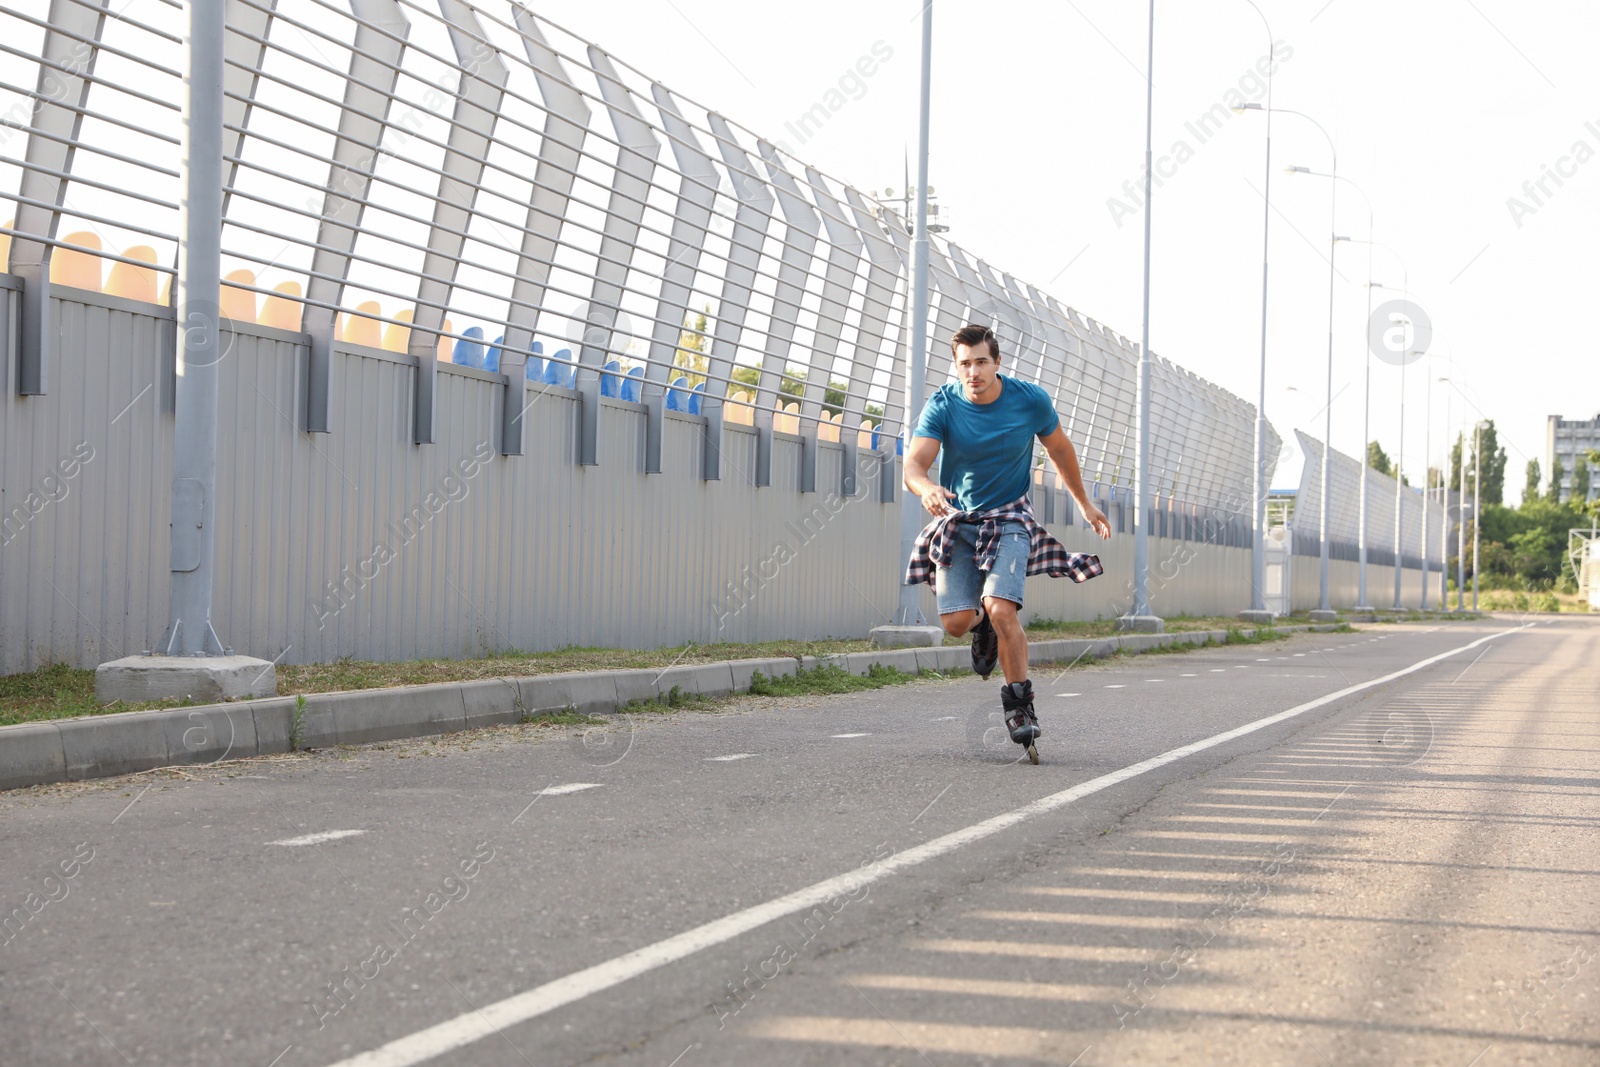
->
[0, 286, 1446, 673]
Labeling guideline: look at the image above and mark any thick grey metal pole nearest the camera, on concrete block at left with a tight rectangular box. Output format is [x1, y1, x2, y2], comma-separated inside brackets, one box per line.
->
[162, 3, 224, 656]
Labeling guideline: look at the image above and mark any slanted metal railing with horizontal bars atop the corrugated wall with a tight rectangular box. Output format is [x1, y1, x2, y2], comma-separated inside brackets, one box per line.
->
[0, 0, 1277, 518]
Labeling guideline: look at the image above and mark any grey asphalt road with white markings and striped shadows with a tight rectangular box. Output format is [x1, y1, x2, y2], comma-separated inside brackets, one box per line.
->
[0, 617, 1600, 1067]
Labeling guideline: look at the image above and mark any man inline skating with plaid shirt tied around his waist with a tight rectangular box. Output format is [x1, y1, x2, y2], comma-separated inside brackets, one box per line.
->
[906, 325, 1110, 763]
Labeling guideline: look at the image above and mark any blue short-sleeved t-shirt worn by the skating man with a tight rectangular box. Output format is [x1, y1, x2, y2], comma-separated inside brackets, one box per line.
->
[914, 374, 1061, 512]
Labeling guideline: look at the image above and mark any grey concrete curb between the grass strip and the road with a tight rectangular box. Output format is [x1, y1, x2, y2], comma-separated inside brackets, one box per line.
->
[0, 625, 1338, 790]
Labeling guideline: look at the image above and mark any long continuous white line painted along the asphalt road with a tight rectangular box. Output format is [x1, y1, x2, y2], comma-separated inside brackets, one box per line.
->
[318, 624, 1528, 1067]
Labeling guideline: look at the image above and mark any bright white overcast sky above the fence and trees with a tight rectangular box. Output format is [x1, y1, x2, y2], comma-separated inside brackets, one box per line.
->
[531, 0, 1600, 502]
